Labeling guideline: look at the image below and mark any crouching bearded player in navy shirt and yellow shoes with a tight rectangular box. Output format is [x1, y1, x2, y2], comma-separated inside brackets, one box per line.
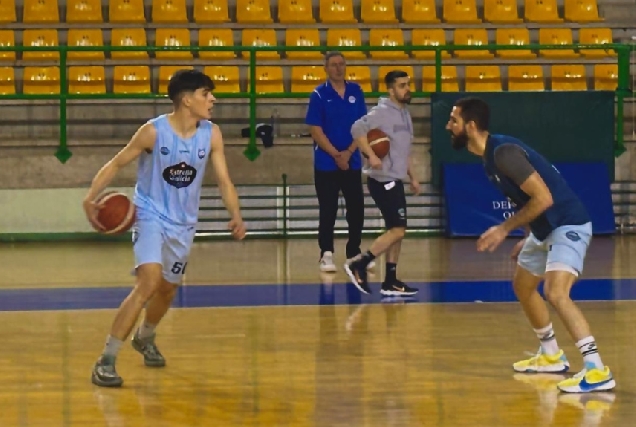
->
[446, 98, 616, 393]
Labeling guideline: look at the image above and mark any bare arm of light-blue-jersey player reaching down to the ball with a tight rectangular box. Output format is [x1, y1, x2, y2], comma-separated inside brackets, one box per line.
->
[84, 123, 157, 203]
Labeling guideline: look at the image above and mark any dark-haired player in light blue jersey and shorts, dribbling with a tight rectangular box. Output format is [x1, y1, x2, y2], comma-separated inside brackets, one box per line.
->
[84, 70, 245, 387]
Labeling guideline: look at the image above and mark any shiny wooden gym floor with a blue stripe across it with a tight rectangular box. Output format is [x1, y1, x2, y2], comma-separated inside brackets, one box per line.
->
[0, 237, 636, 427]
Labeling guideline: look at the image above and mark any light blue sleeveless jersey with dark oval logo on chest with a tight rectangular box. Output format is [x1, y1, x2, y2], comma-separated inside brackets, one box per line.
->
[134, 114, 212, 225]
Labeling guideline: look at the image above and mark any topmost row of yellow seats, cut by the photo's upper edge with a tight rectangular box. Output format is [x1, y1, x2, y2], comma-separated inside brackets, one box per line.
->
[0, 0, 603, 25]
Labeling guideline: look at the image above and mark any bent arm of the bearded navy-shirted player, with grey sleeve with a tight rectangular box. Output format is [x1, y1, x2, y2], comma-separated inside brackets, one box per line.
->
[495, 144, 553, 236]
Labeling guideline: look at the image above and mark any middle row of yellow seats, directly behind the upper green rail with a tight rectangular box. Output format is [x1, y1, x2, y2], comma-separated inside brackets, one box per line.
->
[0, 27, 615, 61]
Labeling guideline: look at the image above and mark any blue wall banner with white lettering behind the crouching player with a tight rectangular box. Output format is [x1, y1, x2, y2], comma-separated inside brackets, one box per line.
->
[443, 162, 615, 237]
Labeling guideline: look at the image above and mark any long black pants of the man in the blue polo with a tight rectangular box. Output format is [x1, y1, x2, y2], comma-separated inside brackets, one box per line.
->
[314, 169, 364, 258]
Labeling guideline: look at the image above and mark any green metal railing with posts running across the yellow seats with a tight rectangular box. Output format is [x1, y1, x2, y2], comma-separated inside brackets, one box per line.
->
[0, 43, 634, 163]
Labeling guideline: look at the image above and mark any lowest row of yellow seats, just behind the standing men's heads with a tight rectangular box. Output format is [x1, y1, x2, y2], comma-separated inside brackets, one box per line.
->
[0, 64, 618, 95]
